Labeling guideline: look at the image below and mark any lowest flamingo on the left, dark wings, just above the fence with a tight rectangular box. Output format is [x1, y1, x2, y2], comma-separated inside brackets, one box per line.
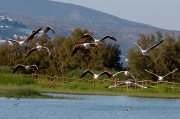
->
[13, 64, 38, 73]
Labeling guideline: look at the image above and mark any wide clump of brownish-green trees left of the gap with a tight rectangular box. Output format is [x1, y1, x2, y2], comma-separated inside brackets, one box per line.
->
[0, 28, 121, 76]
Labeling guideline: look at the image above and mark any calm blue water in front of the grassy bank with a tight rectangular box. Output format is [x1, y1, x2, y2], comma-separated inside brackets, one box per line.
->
[0, 94, 180, 119]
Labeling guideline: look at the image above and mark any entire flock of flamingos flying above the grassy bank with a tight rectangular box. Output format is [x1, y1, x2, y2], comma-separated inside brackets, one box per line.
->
[4, 25, 178, 88]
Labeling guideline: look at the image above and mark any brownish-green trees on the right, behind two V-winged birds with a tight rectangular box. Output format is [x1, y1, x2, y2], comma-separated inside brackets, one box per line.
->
[128, 31, 180, 81]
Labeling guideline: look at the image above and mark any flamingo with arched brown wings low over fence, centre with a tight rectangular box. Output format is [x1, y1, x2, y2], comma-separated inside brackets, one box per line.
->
[80, 69, 112, 80]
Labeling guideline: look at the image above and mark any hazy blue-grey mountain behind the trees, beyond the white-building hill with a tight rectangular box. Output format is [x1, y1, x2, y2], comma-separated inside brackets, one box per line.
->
[0, 0, 180, 54]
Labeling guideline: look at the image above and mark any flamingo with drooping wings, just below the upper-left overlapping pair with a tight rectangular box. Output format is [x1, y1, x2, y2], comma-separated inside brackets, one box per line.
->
[25, 43, 53, 59]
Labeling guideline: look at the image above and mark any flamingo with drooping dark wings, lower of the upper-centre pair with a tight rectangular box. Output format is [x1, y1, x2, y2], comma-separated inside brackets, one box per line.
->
[71, 43, 99, 57]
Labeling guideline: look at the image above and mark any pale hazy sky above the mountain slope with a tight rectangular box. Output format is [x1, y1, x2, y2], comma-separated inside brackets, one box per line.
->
[50, 0, 180, 30]
